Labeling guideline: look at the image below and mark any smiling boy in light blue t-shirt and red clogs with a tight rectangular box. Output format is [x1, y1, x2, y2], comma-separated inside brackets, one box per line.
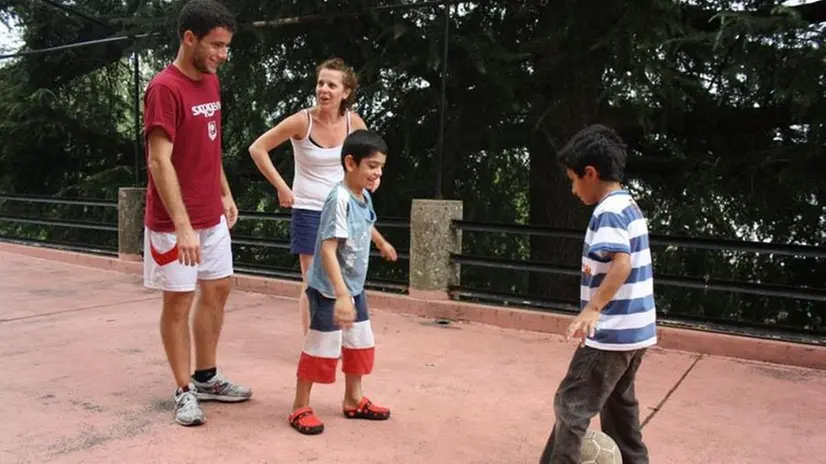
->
[288, 129, 395, 435]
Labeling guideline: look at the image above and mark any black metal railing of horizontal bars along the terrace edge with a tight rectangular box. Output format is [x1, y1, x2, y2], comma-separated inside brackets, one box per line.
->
[0, 194, 826, 339]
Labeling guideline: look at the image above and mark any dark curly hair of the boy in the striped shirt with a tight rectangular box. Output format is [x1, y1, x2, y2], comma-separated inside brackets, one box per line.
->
[558, 124, 627, 182]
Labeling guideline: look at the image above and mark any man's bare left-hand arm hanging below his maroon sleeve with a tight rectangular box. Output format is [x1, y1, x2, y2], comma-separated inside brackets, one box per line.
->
[147, 129, 190, 230]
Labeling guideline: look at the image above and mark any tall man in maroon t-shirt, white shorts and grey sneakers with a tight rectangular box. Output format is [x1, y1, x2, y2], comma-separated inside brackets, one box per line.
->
[144, 0, 252, 425]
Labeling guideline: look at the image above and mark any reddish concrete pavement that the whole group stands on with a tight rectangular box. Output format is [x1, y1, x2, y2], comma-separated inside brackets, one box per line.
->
[0, 251, 826, 464]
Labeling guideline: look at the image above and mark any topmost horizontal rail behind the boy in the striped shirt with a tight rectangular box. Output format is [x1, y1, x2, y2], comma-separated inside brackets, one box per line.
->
[453, 220, 826, 258]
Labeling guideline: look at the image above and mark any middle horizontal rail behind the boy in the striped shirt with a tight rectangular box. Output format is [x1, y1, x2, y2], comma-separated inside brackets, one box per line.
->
[451, 254, 826, 301]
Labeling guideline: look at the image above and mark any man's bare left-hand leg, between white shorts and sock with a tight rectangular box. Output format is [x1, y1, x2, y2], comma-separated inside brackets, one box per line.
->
[161, 292, 194, 388]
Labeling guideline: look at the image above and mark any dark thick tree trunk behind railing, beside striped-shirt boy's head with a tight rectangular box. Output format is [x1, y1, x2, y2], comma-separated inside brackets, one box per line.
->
[528, 0, 621, 302]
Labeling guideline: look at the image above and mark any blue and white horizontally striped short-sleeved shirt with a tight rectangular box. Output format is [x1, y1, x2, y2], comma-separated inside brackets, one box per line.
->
[580, 190, 657, 351]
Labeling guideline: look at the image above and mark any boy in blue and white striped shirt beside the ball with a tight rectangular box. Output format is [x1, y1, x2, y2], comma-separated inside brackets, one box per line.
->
[540, 124, 657, 464]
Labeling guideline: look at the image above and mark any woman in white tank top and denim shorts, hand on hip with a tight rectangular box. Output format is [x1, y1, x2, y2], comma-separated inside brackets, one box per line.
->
[249, 58, 396, 334]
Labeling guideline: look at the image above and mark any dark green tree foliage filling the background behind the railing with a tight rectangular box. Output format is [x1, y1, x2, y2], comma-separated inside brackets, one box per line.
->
[0, 0, 826, 330]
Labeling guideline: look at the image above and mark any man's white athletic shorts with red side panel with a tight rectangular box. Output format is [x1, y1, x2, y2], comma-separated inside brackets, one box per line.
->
[143, 215, 233, 292]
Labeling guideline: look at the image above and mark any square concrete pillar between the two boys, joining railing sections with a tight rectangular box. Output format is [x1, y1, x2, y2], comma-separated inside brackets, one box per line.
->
[409, 200, 463, 300]
